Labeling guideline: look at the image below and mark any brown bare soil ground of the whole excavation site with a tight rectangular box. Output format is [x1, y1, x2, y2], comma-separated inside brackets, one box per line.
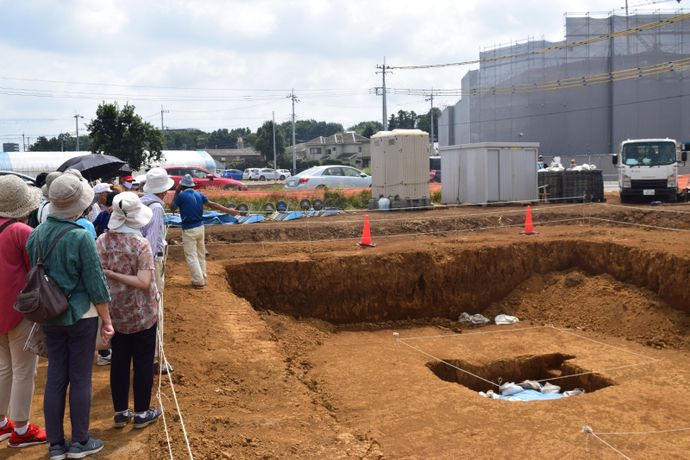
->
[9, 195, 690, 459]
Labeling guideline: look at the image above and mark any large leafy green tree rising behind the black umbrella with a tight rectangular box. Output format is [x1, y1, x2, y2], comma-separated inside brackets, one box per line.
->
[86, 101, 164, 171]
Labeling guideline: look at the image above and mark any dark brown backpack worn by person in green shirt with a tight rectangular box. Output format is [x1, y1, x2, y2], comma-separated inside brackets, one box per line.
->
[14, 227, 80, 323]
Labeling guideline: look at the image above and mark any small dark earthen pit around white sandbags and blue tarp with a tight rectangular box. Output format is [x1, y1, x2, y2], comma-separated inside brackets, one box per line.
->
[427, 353, 615, 393]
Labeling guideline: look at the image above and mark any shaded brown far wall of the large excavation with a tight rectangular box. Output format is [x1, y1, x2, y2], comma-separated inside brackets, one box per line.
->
[226, 240, 690, 324]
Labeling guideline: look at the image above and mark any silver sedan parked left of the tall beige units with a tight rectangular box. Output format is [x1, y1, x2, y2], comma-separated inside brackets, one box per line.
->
[285, 165, 371, 190]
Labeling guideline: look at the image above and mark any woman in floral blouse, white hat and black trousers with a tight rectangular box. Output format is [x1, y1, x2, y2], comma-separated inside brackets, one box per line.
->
[96, 192, 160, 428]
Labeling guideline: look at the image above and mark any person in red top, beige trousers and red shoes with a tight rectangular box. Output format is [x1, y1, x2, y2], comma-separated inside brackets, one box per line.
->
[0, 175, 46, 447]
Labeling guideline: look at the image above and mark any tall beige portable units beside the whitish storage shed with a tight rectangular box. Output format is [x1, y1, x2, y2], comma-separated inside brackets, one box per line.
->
[370, 129, 431, 208]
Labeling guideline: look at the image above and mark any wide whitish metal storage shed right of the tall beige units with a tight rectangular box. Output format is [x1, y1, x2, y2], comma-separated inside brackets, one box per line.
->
[439, 142, 539, 204]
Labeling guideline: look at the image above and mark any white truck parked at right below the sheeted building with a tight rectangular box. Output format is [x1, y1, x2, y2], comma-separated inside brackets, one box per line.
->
[613, 139, 690, 203]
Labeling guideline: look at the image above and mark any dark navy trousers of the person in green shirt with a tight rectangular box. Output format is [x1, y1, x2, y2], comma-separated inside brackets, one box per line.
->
[43, 318, 98, 444]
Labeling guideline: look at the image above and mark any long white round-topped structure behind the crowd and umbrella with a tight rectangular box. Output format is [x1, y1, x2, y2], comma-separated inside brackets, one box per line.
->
[0, 150, 216, 177]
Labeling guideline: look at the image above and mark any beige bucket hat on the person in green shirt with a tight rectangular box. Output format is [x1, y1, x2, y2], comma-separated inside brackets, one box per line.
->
[49, 174, 94, 219]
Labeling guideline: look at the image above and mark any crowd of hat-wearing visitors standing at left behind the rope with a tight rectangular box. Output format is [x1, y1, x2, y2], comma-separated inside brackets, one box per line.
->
[0, 168, 174, 460]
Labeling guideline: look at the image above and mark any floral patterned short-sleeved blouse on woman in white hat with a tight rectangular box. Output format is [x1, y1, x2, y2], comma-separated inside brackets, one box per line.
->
[96, 231, 158, 334]
